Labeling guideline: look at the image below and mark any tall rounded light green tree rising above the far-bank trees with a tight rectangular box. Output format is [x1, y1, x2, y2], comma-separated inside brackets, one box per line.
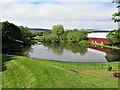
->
[52, 25, 64, 36]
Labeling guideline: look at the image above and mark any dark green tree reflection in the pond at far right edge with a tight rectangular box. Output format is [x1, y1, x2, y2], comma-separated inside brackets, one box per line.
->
[105, 50, 120, 62]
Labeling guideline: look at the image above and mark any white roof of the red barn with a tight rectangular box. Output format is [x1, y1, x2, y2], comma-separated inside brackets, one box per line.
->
[88, 32, 108, 38]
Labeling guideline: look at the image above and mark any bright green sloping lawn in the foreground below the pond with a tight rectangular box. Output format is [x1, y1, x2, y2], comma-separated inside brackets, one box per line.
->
[2, 55, 118, 88]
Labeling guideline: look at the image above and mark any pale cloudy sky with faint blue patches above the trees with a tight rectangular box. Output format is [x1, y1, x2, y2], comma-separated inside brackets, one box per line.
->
[0, 0, 118, 30]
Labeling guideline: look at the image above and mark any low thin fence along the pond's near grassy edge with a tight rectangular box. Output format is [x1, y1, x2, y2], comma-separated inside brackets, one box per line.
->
[51, 61, 117, 69]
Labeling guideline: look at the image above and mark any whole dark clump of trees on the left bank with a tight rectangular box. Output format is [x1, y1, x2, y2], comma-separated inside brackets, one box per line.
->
[0, 21, 39, 49]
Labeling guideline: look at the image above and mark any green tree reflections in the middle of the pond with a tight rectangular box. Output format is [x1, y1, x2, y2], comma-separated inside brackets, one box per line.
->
[43, 43, 87, 55]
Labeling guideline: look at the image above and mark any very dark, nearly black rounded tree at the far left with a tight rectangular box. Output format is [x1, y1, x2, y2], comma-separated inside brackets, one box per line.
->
[2, 21, 22, 43]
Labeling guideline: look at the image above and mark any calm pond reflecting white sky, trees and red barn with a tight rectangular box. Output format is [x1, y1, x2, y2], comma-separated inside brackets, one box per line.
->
[12, 43, 120, 62]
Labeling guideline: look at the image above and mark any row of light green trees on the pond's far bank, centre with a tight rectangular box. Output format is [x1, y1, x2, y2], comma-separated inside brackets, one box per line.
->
[40, 25, 88, 44]
